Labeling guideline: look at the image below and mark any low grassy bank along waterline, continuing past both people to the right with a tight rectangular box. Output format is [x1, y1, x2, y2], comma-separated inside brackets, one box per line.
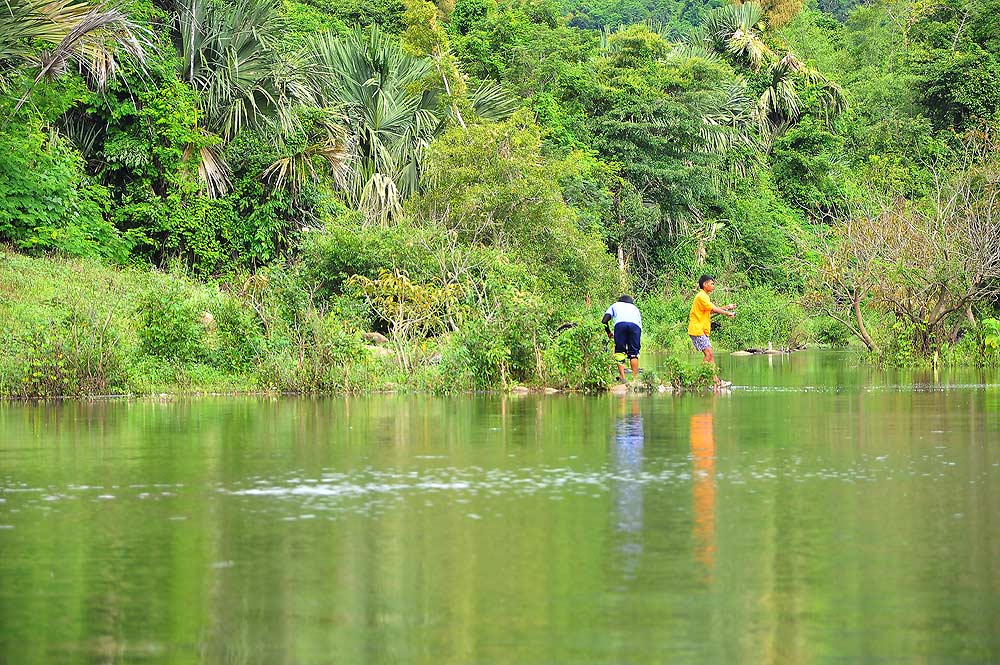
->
[7, 246, 996, 399]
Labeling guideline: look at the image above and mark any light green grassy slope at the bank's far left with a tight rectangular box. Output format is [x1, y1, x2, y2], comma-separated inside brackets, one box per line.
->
[0, 248, 257, 397]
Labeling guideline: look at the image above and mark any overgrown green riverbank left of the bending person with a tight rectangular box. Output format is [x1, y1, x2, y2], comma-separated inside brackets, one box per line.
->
[0, 249, 676, 399]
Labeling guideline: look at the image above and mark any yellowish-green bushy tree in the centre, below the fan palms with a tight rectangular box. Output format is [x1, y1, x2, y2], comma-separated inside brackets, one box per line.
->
[408, 110, 610, 301]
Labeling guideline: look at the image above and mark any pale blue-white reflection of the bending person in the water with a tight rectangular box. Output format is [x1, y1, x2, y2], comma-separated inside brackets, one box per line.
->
[612, 397, 644, 579]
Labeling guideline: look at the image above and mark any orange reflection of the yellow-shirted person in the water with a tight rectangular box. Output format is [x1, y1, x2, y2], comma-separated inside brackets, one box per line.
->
[691, 411, 715, 580]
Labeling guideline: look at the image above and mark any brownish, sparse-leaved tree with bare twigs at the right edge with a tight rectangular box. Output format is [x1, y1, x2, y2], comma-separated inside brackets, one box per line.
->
[823, 130, 1000, 354]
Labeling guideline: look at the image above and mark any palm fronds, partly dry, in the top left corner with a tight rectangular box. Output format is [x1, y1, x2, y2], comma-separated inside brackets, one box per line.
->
[0, 0, 147, 113]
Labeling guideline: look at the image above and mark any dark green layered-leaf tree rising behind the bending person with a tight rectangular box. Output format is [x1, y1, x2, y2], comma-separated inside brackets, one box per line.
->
[576, 26, 752, 285]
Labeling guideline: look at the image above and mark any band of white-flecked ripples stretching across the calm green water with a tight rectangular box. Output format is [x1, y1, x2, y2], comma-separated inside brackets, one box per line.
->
[0, 452, 976, 520]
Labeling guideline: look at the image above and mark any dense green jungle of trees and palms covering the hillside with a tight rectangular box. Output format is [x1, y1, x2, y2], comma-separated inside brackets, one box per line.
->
[0, 0, 1000, 394]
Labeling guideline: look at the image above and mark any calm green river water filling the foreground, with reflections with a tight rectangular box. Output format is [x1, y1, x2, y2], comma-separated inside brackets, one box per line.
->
[0, 351, 1000, 665]
